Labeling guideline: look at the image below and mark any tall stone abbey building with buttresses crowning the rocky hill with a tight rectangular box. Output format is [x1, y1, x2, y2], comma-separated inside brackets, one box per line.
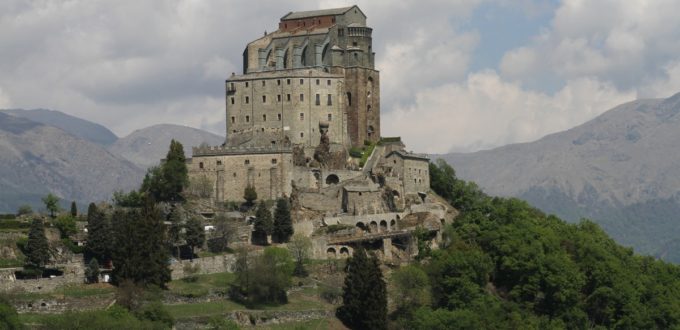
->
[226, 6, 380, 147]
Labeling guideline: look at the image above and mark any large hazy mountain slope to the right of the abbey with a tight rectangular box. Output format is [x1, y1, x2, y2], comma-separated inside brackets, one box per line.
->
[442, 94, 680, 262]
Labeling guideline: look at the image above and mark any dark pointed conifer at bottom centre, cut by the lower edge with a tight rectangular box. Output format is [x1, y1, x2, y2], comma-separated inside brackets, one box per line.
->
[336, 248, 387, 329]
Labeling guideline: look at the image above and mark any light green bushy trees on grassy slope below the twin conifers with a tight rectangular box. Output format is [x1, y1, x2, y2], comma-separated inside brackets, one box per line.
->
[231, 247, 294, 304]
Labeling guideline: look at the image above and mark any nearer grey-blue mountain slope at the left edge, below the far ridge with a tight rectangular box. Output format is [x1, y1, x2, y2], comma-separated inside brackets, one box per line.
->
[0, 112, 144, 212]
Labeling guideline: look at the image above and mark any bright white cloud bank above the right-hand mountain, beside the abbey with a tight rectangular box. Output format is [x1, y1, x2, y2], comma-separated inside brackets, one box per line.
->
[383, 71, 635, 153]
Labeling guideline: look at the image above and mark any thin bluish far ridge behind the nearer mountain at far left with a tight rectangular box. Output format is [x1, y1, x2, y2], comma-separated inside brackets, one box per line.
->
[1, 109, 118, 146]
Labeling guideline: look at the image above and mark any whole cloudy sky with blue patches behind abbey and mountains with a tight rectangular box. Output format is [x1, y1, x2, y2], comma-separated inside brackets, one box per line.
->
[0, 0, 680, 153]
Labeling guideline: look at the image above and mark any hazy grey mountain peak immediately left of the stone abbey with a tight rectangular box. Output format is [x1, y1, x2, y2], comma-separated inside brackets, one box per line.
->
[109, 124, 224, 169]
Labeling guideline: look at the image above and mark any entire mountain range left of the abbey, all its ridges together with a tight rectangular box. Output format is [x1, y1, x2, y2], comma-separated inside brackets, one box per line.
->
[0, 109, 224, 213]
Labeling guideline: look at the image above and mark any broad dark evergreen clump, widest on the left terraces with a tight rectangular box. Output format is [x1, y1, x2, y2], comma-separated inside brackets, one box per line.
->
[113, 200, 170, 287]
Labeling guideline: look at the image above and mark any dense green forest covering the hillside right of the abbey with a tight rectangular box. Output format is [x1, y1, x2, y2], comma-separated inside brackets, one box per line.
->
[403, 162, 680, 329]
